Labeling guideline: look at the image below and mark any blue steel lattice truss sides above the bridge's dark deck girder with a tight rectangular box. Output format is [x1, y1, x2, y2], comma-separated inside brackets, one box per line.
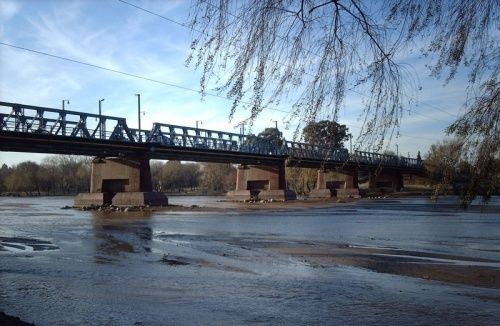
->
[0, 102, 423, 168]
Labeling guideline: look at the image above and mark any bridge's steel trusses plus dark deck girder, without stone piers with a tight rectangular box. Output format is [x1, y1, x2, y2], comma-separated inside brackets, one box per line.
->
[0, 101, 423, 172]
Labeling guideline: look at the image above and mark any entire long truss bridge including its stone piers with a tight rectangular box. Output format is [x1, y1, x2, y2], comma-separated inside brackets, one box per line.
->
[0, 102, 423, 203]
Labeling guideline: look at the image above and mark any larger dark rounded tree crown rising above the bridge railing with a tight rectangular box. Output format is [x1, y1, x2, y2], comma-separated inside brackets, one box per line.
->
[302, 120, 349, 148]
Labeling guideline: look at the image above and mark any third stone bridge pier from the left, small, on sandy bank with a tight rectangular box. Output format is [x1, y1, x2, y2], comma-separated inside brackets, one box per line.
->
[309, 169, 359, 198]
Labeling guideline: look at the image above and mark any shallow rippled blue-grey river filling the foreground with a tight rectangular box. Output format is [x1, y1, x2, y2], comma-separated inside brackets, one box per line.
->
[0, 197, 500, 325]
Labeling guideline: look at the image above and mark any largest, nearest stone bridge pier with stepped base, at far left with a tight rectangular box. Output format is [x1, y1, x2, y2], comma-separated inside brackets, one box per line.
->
[75, 158, 168, 206]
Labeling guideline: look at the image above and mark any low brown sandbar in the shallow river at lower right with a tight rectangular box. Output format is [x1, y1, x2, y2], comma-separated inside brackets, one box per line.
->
[268, 243, 500, 292]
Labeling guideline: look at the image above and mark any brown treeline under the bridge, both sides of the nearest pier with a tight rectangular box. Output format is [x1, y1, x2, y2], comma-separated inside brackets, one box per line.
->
[0, 155, 240, 195]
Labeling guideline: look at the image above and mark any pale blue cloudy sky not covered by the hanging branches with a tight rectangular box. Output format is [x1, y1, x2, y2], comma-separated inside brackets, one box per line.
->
[0, 0, 467, 166]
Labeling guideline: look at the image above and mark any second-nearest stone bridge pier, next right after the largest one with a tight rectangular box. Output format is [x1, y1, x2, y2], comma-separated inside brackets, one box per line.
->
[227, 164, 297, 201]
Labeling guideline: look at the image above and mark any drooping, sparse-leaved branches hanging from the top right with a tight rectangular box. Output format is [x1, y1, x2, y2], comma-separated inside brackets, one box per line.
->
[187, 0, 500, 204]
